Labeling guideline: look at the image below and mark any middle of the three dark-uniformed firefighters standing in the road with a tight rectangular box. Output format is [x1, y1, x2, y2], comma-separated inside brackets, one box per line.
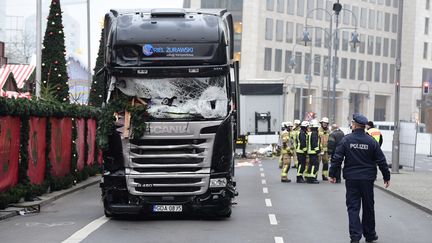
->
[306, 119, 321, 184]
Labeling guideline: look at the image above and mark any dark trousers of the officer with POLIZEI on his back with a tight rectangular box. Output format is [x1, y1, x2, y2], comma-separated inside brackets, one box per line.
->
[345, 180, 376, 240]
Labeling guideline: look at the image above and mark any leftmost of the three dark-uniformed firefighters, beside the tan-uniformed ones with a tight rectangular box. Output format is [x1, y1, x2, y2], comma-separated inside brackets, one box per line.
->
[295, 121, 309, 183]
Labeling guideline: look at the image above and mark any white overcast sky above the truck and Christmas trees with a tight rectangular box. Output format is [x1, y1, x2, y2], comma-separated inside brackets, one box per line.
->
[5, 0, 183, 69]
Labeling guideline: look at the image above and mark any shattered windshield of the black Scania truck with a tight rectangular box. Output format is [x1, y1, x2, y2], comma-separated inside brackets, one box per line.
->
[117, 76, 228, 119]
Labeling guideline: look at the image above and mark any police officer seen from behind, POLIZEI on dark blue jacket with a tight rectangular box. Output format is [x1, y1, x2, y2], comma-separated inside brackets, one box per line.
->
[330, 114, 390, 243]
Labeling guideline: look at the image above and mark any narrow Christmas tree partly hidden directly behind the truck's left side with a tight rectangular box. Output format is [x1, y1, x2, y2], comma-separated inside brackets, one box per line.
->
[88, 29, 105, 107]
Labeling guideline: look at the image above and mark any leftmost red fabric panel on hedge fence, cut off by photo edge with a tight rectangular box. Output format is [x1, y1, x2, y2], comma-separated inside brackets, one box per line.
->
[0, 116, 21, 192]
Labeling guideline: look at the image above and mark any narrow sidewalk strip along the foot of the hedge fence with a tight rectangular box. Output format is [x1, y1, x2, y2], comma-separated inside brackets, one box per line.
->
[0, 175, 101, 220]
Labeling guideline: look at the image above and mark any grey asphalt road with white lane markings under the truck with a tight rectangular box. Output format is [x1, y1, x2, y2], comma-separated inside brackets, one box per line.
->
[0, 160, 432, 243]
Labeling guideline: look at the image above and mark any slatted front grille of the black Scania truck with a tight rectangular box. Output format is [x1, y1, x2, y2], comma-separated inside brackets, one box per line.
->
[126, 129, 218, 196]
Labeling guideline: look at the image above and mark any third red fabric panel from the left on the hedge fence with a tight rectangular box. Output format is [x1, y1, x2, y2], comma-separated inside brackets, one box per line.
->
[49, 118, 72, 177]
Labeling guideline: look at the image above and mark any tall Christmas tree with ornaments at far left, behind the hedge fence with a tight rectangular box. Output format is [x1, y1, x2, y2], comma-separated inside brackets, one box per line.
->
[41, 0, 69, 103]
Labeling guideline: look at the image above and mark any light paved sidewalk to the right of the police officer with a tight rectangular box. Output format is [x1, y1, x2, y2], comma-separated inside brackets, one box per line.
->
[375, 170, 432, 214]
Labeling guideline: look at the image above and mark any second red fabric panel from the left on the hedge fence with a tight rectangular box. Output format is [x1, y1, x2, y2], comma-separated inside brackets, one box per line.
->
[27, 117, 47, 185]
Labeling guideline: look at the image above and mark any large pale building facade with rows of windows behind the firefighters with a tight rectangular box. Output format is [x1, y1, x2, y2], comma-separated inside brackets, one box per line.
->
[185, 0, 422, 129]
